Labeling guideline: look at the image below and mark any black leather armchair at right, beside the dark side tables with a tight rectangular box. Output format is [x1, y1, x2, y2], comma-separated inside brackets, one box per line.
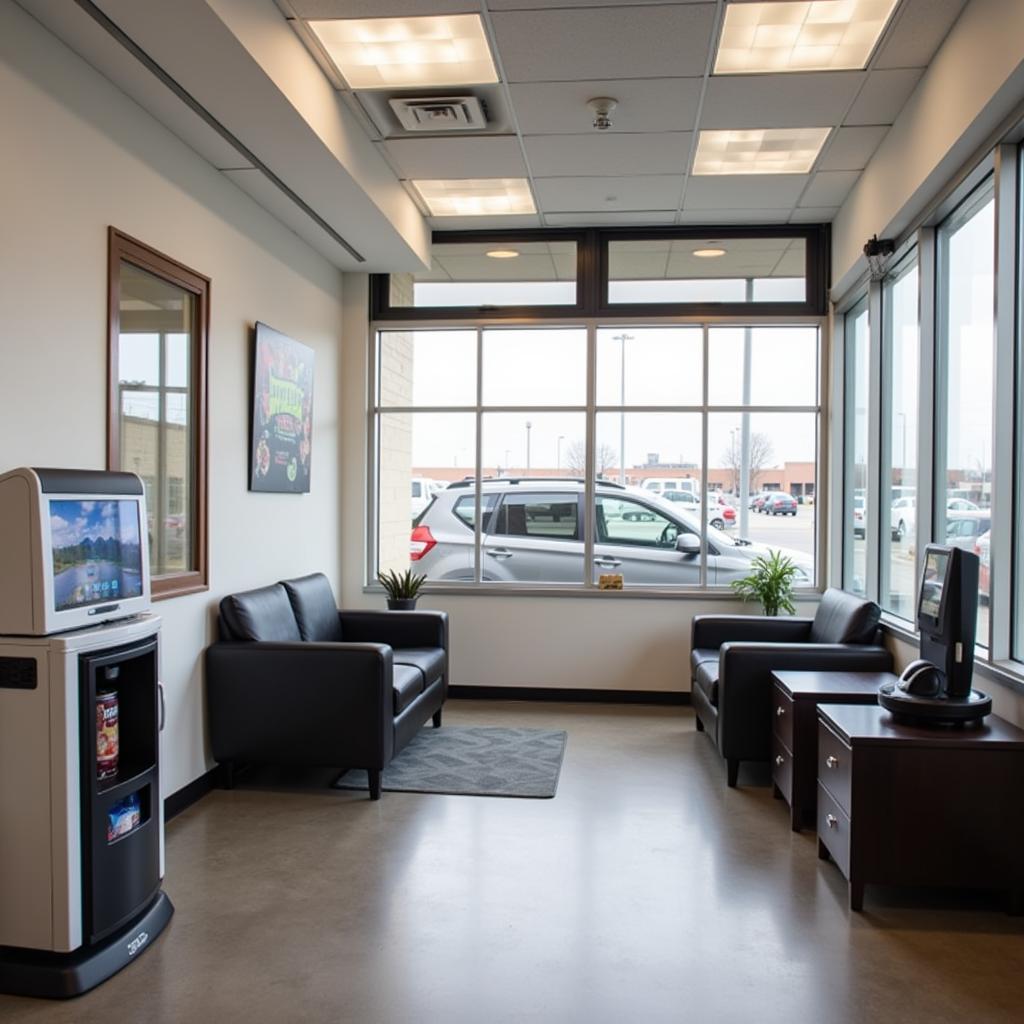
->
[690, 589, 892, 785]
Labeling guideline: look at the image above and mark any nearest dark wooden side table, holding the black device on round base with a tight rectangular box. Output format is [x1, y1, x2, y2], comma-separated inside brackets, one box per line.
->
[817, 703, 1024, 913]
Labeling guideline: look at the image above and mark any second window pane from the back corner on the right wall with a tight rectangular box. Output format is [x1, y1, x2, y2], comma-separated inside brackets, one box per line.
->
[879, 253, 921, 620]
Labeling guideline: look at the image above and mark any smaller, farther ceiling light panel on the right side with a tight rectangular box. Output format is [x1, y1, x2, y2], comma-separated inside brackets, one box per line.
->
[693, 128, 831, 174]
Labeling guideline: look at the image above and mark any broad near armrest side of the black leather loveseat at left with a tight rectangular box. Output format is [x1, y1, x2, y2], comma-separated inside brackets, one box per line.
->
[206, 642, 394, 768]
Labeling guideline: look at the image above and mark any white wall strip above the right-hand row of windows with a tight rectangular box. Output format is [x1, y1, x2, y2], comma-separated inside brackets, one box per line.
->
[833, 0, 1024, 296]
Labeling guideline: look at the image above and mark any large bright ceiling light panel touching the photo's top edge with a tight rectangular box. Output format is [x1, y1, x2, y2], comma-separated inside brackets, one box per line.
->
[715, 0, 899, 75]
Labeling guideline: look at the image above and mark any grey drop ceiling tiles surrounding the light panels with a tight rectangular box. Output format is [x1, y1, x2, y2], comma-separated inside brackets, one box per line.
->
[301, 0, 966, 228]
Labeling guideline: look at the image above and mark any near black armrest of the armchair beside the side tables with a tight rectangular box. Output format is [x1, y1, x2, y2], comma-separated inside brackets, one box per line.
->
[718, 642, 893, 761]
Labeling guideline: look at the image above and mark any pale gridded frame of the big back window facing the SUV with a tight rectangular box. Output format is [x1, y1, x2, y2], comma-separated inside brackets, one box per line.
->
[364, 315, 830, 601]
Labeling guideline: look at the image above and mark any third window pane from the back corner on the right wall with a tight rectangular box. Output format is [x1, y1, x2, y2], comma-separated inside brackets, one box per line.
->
[934, 184, 995, 644]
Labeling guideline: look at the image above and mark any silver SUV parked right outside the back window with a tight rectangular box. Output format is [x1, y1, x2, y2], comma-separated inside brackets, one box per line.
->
[410, 477, 814, 586]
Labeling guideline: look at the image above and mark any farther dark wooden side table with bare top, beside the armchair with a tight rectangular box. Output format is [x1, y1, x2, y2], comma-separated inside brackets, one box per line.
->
[771, 671, 896, 831]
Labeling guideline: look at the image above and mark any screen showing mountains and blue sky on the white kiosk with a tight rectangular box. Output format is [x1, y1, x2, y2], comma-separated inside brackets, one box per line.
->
[49, 499, 142, 611]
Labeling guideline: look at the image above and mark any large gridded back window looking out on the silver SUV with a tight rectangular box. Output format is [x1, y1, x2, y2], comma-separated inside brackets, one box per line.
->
[368, 322, 820, 588]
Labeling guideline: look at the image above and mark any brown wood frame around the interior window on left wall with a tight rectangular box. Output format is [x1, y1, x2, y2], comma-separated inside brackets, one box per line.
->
[106, 227, 210, 601]
